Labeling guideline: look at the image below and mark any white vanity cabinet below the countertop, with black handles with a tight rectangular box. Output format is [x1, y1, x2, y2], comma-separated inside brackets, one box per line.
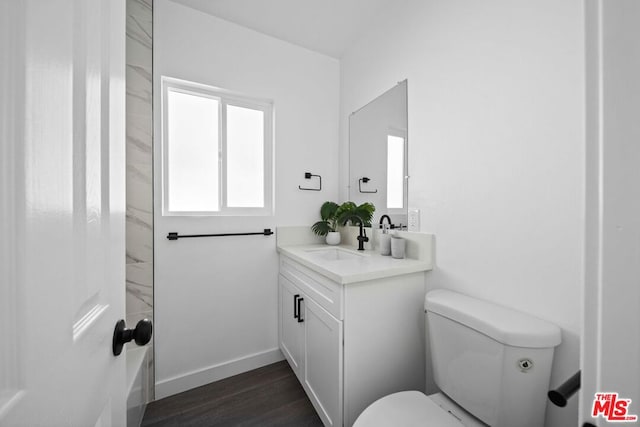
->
[279, 252, 425, 427]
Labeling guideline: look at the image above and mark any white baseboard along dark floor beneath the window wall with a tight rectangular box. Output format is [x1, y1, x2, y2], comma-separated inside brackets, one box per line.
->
[156, 348, 284, 400]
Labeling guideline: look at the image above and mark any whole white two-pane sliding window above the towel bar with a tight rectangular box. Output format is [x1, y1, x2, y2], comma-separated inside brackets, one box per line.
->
[162, 77, 273, 215]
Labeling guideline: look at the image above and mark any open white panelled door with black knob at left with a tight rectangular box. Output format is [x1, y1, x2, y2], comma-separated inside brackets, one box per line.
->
[0, 0, 126, 427]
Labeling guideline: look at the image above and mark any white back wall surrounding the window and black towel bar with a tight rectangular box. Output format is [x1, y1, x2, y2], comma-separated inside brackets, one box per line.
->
[154, 0, 340, 397]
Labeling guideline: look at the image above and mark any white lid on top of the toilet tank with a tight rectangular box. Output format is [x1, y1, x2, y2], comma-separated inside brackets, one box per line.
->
[425, 289, 562, 348]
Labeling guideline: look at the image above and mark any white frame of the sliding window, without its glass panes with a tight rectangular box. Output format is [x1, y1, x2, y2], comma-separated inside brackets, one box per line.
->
[161, 76, 274, 217]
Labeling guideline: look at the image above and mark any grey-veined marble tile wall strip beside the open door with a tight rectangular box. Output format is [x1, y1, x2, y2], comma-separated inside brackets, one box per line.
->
[126, 0, 155, 400]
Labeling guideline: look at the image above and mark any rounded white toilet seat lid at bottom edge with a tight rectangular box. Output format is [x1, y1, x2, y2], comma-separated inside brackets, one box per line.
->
[353, 391, 464, 427]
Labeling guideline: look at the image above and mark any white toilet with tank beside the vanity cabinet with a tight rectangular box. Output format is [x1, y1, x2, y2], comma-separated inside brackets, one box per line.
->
[353, 289, 561, 427]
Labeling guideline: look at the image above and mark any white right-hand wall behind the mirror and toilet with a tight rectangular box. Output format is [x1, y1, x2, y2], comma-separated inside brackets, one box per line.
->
[340, 0, 585, 427]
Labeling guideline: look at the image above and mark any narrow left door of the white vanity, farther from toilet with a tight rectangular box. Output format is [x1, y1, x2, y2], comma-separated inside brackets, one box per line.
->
[279, 275, 304, 380]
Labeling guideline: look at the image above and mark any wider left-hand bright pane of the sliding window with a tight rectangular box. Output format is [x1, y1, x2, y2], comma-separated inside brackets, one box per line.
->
[167, 90, 220, 212]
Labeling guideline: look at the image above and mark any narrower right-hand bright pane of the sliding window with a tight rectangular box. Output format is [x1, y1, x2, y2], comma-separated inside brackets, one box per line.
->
[227, 105, 264, 208]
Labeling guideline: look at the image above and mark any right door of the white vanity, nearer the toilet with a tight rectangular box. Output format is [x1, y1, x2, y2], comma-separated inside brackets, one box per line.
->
[302, 298, 343, 426]
